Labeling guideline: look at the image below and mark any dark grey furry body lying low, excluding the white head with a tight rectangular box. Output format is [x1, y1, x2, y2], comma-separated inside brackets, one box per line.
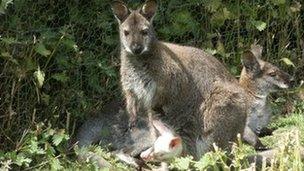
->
[74, 101, 155, 167]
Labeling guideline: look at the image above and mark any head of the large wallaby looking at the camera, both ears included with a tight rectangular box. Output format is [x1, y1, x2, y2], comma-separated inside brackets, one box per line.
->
[112, 0, 157, 55]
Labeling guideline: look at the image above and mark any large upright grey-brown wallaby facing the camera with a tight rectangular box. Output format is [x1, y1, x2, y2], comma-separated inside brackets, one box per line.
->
[112, 0, 246, 158]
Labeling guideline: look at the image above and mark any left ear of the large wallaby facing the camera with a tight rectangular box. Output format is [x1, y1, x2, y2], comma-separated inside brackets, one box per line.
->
[111, 1, 130, 23]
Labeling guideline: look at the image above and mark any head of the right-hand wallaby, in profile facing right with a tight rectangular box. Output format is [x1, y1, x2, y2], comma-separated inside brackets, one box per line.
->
[240, 45, 291, 93]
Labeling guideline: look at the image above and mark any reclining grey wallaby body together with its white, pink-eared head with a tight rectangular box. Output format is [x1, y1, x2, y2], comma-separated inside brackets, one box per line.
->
[74, 101, 182, 168]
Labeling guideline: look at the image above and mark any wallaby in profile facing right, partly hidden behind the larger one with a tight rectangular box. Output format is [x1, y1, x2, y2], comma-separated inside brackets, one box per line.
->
[239, 44, 291, 149]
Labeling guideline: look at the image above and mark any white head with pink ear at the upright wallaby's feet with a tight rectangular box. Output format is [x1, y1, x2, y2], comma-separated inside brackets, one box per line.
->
[140, 120, 183, 161]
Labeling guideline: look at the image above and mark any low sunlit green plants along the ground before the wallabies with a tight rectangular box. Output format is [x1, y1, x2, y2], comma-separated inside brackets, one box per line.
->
[0, 99, 304, 171]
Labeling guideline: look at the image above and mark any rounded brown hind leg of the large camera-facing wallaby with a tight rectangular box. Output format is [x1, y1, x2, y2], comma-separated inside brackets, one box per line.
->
[202, 85, 247, 155]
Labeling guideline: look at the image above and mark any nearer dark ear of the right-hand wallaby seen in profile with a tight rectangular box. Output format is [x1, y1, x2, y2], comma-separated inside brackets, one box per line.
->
[242, 51, 261, 76]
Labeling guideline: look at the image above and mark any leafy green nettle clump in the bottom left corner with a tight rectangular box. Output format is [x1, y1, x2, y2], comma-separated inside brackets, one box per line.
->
[0, 123, 69, 170]
